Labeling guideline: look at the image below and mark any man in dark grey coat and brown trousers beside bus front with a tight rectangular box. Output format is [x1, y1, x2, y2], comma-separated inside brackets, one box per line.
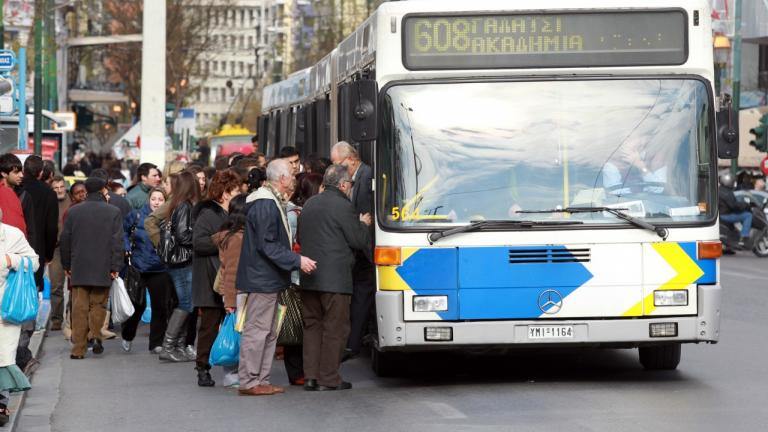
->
[298, 165, 371, 390]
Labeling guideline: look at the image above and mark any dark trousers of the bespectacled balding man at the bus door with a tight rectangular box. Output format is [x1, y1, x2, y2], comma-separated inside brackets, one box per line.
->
[347, 262, 376, 353]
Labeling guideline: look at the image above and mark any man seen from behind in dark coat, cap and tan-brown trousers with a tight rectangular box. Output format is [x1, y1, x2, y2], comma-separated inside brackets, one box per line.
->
[59, 177, 123, 359]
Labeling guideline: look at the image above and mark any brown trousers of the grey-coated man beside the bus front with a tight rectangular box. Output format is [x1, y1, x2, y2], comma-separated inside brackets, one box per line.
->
[301, 291, 351, 387]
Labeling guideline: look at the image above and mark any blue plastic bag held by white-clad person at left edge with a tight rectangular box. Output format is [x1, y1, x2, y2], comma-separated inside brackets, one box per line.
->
[0, 257, 38, 324]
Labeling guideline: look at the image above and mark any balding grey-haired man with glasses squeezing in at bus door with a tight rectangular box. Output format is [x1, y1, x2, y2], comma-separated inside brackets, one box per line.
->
[331, 141, 376, 361]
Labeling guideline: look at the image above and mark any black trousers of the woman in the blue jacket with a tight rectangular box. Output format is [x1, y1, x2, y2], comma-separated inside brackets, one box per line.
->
[121, 273, 174, 350]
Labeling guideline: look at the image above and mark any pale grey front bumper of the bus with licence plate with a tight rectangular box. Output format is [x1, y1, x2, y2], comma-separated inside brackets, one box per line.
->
[376, 285, 722, 351]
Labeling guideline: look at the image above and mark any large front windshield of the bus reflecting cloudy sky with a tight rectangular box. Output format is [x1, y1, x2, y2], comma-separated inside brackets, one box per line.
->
[377, 79, 716, 228]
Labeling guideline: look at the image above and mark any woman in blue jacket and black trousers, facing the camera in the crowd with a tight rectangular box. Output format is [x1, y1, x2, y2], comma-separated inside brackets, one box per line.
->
[121, 188, 173, 354]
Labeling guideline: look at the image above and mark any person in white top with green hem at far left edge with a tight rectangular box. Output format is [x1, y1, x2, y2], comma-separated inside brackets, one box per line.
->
[0, 211, 39, 426]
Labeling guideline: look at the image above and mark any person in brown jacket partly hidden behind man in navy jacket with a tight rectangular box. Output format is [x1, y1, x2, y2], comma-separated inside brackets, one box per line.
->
[212, 194, 246, 387]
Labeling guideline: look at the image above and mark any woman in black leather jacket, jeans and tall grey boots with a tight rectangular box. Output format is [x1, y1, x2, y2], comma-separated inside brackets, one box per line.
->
[158, 171, 200, 362]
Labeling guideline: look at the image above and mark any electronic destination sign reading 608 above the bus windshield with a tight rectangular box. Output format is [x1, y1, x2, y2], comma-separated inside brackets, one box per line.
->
[403, 10, 687, 70]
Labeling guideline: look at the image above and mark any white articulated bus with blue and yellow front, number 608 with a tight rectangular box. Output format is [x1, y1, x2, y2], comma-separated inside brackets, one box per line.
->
[259, 0, 737, 374]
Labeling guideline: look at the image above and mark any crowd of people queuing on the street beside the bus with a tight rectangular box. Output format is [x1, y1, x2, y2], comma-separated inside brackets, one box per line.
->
[0, 138, 375, 416]
